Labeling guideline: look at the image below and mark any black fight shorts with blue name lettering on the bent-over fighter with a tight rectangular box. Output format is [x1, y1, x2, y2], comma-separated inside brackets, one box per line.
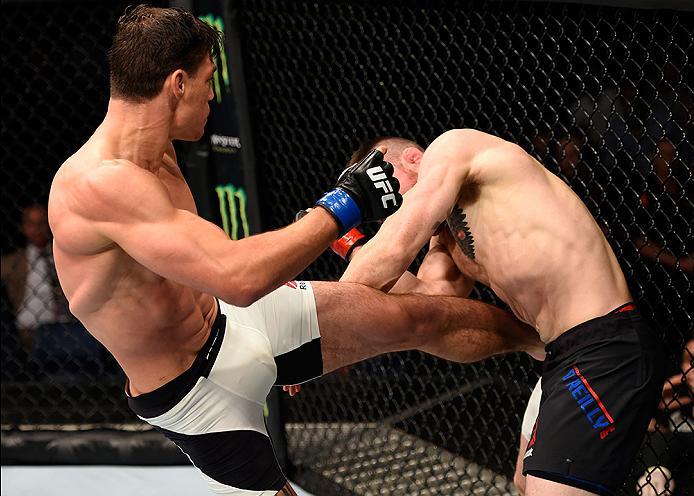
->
[523, 304, 665, 495]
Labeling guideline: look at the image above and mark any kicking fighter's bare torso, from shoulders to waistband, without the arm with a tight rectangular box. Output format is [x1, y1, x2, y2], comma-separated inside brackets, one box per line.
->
[48, 132, 217, 394]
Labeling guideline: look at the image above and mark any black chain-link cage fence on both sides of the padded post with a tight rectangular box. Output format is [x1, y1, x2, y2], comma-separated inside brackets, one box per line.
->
[0, 0, 694, 496]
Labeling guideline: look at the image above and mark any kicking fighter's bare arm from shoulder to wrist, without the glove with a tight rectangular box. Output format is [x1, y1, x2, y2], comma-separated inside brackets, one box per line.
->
[73, 162, 337, 306]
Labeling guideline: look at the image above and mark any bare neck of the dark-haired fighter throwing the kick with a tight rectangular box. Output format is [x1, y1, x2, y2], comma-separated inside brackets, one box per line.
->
[99, 97, 171, 172]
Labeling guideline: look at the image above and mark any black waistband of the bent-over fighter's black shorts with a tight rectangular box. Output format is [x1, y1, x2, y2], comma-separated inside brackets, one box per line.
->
[545, 303, 640, 359]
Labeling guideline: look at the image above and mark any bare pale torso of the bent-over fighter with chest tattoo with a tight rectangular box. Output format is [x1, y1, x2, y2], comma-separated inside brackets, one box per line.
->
[439, 154, 631, 342]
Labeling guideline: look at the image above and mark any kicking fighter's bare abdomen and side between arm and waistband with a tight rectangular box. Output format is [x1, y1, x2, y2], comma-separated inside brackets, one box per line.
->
[56, 248, 216, 392]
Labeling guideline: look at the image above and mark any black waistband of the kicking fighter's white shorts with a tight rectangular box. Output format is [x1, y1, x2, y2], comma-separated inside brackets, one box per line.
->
[128, 305, 226, 418]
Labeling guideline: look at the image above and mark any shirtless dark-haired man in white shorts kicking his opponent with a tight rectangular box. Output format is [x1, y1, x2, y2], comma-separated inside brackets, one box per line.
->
[48, 6, 539, 496]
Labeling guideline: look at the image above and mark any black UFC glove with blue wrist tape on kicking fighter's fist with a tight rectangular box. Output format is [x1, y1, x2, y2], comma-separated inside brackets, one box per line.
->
[316, 150, 402, 236]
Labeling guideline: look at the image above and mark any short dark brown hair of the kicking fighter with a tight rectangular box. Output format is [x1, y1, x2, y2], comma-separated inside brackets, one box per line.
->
[109, 5, 222, 102]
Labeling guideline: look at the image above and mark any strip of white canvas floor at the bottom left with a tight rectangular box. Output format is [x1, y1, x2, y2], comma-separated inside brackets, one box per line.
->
[0, 466, 312, 496]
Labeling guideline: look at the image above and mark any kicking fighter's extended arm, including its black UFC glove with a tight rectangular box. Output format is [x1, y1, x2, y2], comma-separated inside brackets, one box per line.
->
[63, 142, 402, 306]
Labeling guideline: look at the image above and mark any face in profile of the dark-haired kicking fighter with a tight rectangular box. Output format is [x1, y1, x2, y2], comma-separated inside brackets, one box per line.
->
[172, 57, 215, 141]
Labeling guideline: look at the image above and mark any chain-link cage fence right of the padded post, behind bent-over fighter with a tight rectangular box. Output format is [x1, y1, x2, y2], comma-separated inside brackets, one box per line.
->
[240, 1, 694, 495]
